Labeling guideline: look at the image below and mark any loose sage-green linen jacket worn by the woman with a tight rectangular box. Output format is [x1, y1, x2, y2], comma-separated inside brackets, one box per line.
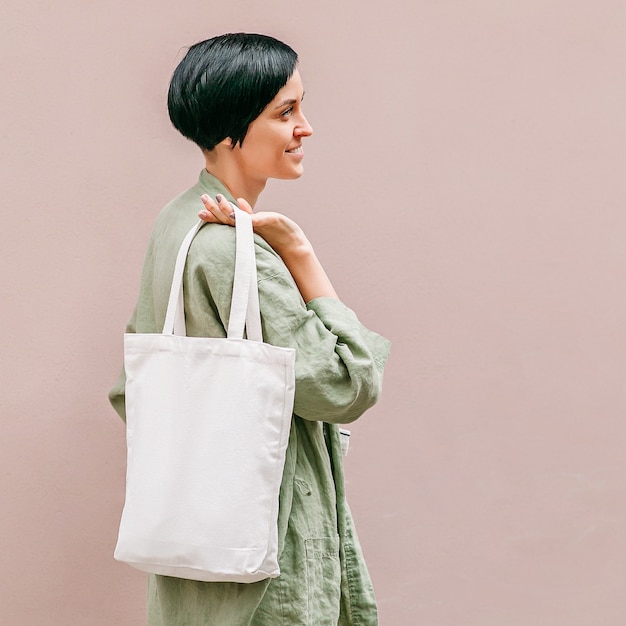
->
[109, 170, 390, 626]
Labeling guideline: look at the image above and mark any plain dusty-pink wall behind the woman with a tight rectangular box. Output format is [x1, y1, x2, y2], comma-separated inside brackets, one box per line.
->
[0, 0, 626, 626]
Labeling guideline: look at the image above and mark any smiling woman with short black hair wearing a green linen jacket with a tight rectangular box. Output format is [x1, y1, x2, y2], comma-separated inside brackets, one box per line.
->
[110, 33, 389, 626]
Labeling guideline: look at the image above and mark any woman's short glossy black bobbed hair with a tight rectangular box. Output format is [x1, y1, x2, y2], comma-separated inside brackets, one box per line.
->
[167, 33, 298, 150]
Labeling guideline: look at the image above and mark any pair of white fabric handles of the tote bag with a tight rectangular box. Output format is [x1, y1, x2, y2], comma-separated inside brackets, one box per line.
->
[163, 205, 263, 341]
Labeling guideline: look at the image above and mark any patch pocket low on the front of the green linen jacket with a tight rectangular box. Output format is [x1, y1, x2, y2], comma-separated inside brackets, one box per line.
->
[305, 535, 341, 626]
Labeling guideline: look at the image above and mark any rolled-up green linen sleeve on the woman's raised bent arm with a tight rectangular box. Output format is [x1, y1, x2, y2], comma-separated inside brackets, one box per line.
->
[188, 226, 390, 424]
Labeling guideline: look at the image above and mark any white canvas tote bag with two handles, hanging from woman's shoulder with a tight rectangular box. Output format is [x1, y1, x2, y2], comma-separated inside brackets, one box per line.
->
[115, 208, 295, 582]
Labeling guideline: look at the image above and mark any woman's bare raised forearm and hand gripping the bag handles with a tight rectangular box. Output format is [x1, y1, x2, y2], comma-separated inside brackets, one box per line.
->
[199, 195, 337, 302]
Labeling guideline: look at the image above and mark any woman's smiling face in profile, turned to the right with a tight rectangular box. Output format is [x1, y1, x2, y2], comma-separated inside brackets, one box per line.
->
[234, 70, 313, 183]
